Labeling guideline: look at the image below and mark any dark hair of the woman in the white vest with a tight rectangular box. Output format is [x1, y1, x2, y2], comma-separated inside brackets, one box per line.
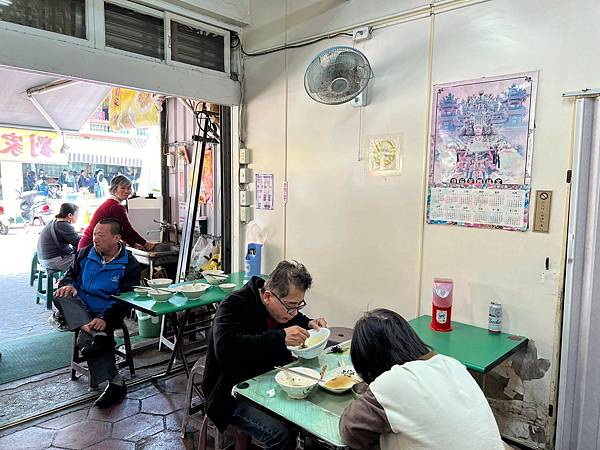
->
[350, 309, 431, 383]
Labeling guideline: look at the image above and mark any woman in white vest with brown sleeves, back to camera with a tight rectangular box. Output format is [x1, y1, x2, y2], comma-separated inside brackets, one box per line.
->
[340, 309, 505, 450]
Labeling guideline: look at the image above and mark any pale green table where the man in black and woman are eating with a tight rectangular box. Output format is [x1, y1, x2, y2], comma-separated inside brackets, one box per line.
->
[233, 351, 353, 448]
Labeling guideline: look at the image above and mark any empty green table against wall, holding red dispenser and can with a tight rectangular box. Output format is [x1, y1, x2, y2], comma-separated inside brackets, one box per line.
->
[409, 316, 527, 374]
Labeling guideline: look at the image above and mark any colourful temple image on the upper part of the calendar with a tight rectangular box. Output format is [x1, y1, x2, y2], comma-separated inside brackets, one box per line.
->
[432, 77, 532, 188]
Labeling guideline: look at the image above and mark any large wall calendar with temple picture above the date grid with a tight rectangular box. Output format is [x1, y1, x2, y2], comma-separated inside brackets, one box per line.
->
[427, 72, 537, 231]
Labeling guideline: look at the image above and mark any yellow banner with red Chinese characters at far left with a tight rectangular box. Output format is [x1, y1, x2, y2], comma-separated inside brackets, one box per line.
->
[0, 128, 67, 164]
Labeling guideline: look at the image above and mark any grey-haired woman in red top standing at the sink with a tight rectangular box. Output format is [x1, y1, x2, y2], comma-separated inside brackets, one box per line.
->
[77, 175, 156, 251]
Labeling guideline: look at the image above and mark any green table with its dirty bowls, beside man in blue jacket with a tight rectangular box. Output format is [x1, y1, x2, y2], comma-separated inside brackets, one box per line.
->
[113, 272, 250, 378]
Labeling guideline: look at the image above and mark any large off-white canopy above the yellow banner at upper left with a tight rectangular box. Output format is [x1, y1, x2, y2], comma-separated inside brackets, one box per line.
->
[0, 67, 110, 131]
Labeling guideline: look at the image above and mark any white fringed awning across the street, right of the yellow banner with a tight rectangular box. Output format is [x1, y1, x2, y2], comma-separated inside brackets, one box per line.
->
[65, 135, 143, 167]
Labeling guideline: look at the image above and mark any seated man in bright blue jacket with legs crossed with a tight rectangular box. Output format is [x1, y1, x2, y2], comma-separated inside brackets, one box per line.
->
[54, 219, 141, 408]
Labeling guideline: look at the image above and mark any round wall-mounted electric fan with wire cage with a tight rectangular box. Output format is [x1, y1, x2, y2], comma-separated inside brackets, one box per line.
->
[304, 46, 373, 105]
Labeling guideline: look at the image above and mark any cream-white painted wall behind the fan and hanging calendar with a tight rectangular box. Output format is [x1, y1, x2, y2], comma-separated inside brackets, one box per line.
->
[243, 0, 600, 448]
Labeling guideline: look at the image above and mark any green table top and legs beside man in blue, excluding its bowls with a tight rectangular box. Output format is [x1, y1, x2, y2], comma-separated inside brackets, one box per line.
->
[112, 272, 250, 378]
